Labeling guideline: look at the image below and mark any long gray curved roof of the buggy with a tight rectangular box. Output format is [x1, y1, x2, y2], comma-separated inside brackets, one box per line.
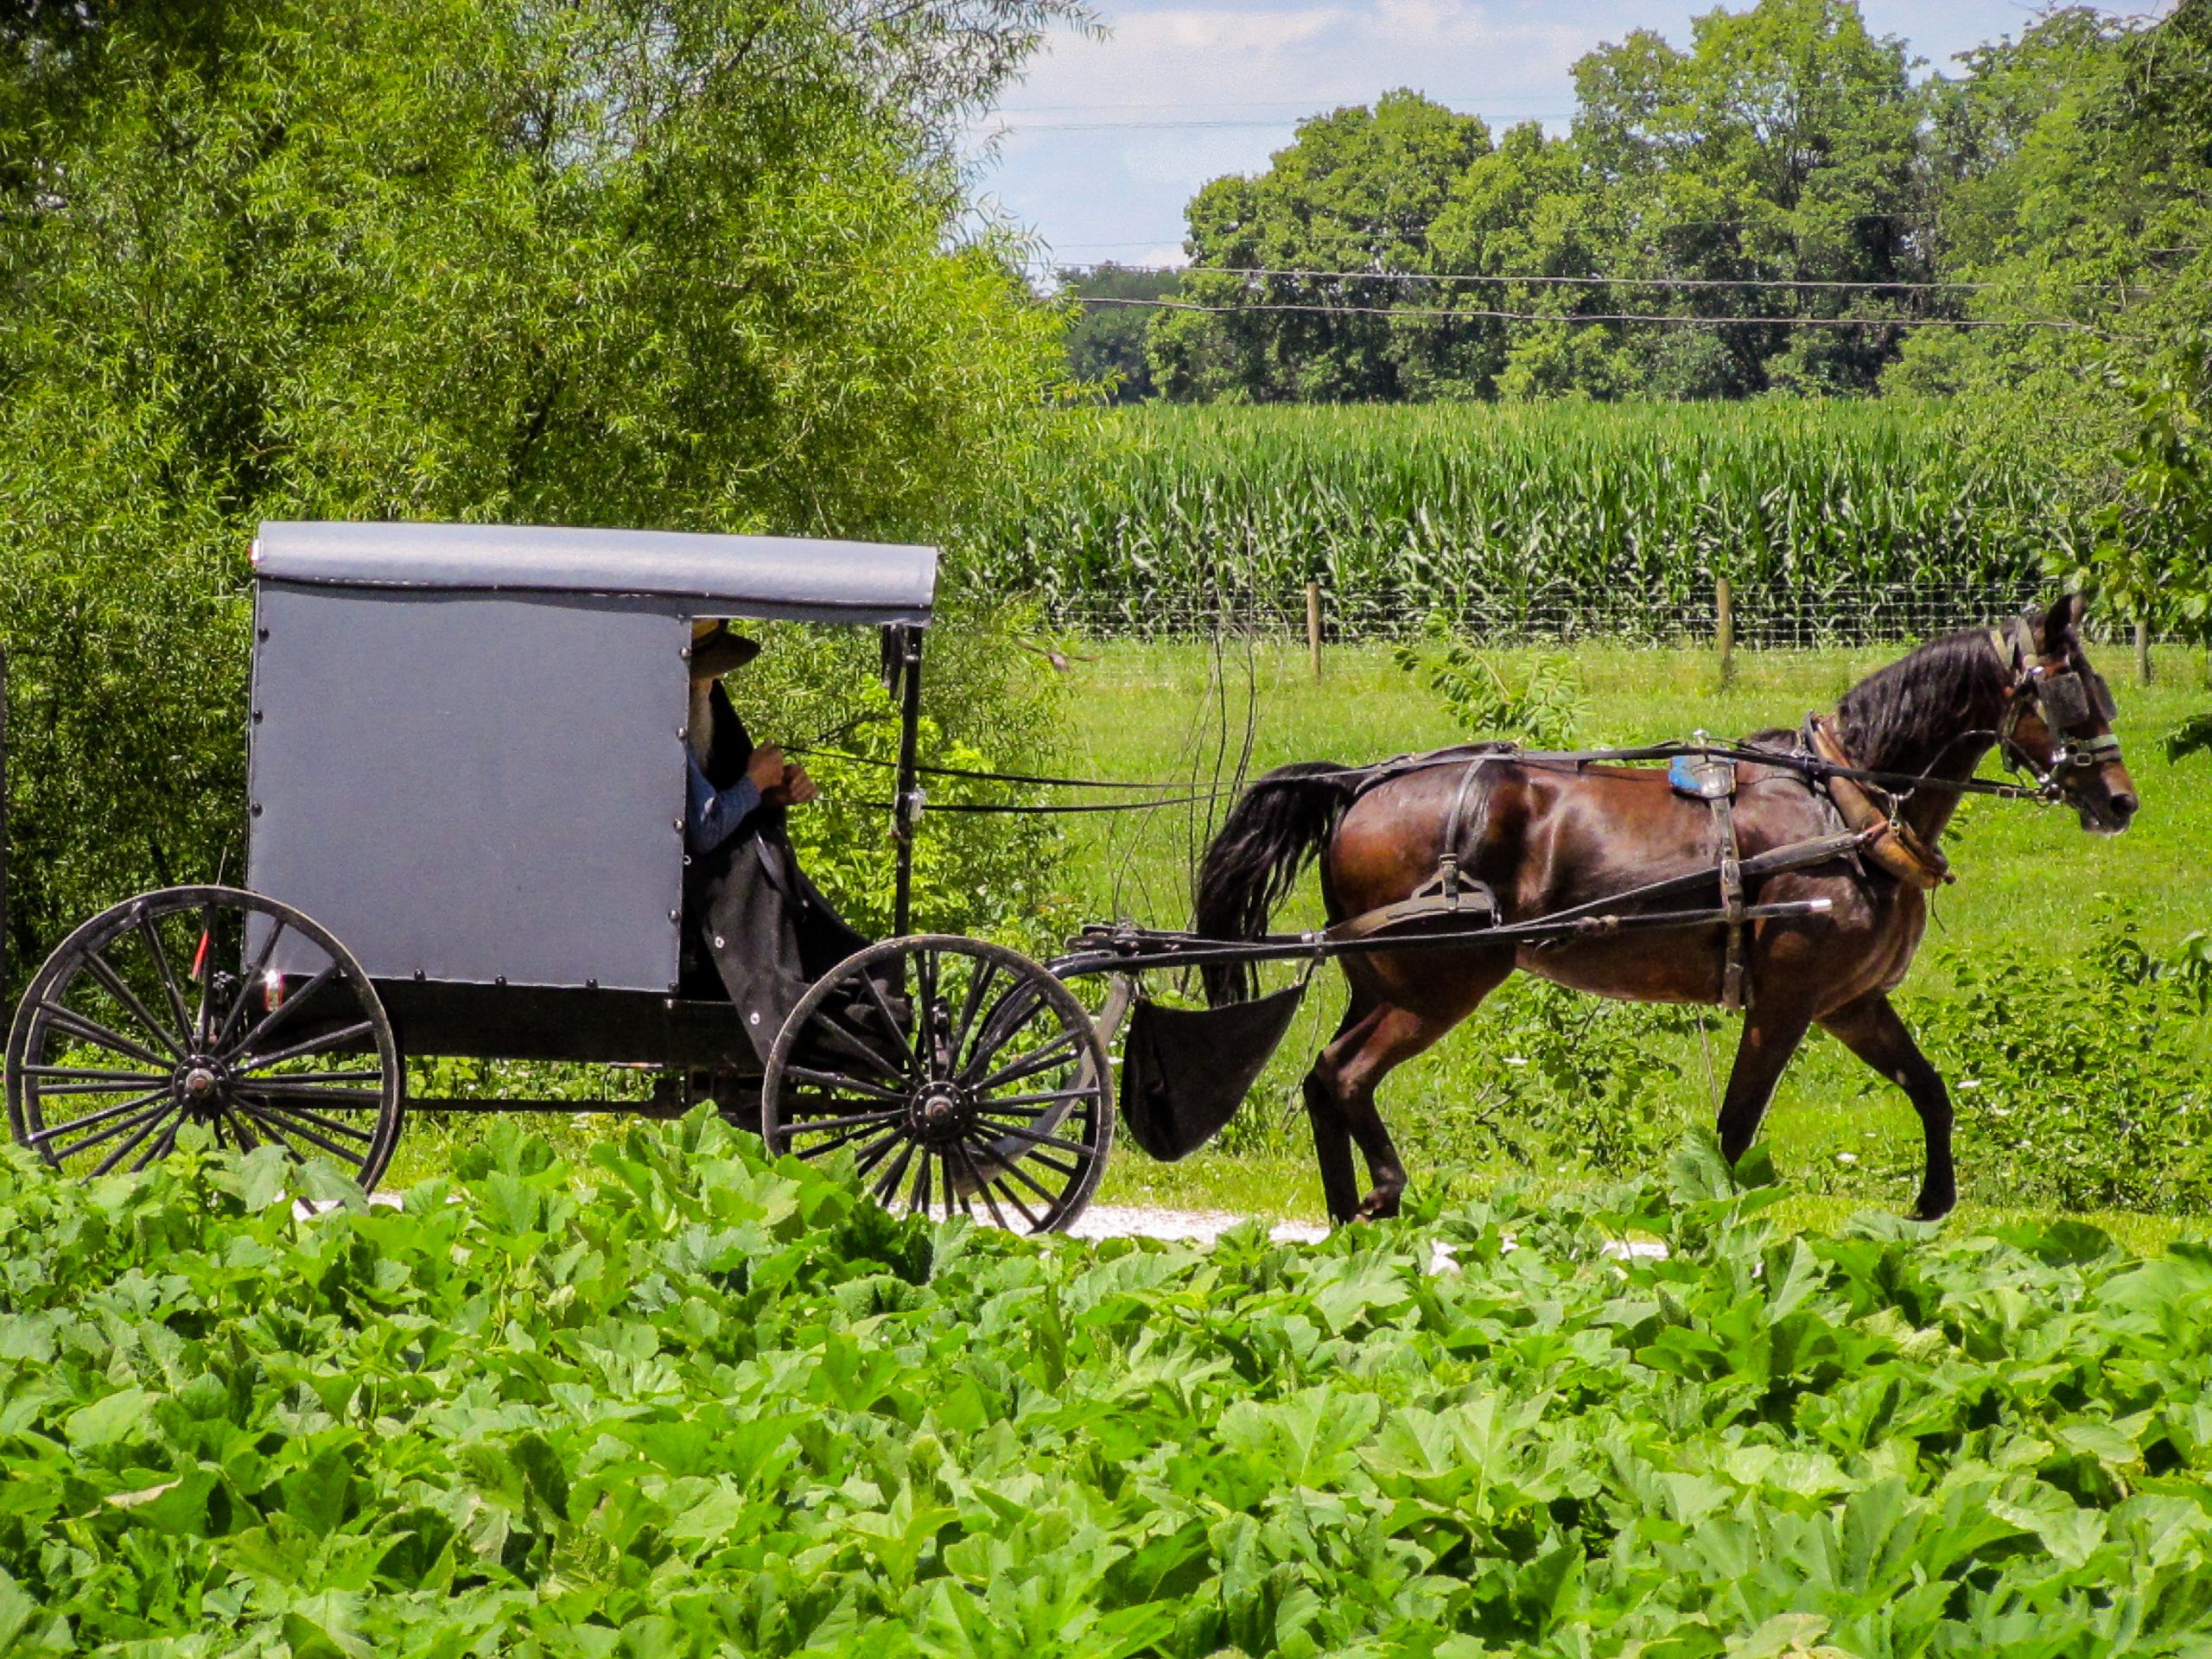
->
[254, 522, 938, 624]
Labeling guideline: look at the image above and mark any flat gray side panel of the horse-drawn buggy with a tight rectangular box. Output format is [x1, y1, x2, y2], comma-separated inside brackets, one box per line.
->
[248, 582, 690, 995]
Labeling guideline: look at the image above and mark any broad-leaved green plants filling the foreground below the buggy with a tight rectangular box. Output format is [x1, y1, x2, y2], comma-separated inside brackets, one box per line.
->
[13, 1115, 2212, 1659]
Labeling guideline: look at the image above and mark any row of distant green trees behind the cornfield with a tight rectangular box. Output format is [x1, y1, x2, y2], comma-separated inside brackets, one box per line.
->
[1123, 0, 2205, 403]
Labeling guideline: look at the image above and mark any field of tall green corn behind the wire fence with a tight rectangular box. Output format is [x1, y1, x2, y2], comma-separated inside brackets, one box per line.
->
[982, 400, 2082, 644]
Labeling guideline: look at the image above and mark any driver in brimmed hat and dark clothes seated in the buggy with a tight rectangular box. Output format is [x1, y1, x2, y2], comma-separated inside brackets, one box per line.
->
[683, 621, 868, 1064]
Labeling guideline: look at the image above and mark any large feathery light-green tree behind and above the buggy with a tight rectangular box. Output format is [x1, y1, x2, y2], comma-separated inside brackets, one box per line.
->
[0, 0, 1075, 964]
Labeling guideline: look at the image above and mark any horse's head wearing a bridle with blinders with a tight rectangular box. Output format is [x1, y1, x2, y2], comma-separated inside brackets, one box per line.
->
[1998, 593, 2141, 836]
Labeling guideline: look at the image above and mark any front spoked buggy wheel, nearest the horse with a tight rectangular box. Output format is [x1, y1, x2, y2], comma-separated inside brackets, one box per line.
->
[761, 936, 1113, 1232]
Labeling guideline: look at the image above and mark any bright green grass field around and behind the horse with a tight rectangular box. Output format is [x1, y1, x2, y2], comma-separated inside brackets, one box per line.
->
[1064, 644, 2212, 1243]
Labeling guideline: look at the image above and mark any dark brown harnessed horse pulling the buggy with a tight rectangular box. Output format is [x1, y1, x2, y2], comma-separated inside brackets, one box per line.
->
[1197, 597, 2137, 1221]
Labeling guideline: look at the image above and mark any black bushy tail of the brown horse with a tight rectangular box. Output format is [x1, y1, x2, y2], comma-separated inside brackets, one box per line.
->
[1197, 761, 1363, 1007]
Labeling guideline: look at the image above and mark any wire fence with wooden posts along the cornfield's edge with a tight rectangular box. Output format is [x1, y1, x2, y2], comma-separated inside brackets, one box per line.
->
[1046, 582, 2179, 651]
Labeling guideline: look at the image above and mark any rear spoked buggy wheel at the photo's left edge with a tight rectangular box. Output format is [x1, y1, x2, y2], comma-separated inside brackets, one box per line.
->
[7, 887, 404, 1185]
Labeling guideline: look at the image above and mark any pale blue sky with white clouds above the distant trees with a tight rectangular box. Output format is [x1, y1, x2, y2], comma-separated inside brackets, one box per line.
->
[978, 0, 2152, 265]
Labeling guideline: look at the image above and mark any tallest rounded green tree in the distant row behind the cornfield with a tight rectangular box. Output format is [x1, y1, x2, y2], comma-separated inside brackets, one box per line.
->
[1575, 0, 1933, 396]
